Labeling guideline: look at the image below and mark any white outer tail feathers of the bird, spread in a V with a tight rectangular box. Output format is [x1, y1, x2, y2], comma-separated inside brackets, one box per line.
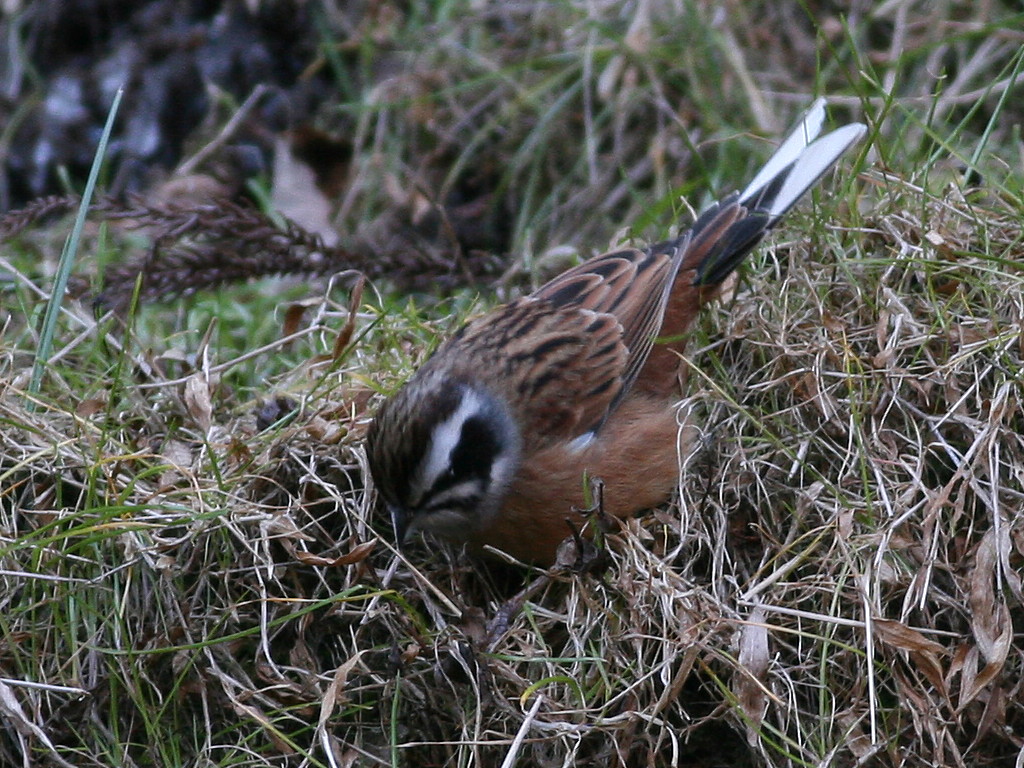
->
[739, 98, 867, 220]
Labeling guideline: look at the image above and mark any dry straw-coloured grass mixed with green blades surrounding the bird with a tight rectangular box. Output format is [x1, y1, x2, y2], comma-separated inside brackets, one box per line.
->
[0, 1, 1024, 766]
